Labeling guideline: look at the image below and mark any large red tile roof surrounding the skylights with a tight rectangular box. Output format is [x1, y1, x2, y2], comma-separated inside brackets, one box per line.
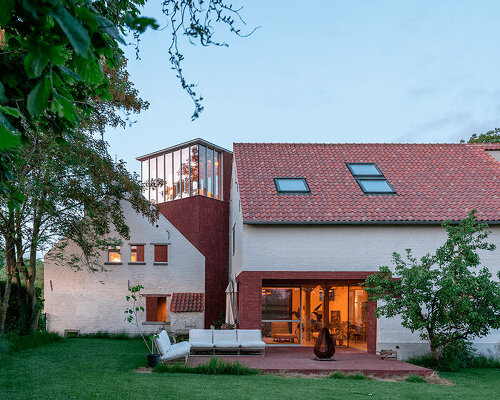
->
[234, 143, 500, 223]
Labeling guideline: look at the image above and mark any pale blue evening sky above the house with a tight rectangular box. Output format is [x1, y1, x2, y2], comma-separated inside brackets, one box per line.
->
[105, 0, 500, 172]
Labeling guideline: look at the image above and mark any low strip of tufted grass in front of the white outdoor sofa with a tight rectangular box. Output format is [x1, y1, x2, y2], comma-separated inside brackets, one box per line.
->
[153, 358, 261, 375]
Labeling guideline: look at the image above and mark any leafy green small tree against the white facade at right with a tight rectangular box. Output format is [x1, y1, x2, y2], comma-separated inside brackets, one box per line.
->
[365, 210, 500, 363]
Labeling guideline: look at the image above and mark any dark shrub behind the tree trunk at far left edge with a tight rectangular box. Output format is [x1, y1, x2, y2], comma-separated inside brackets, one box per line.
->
[0, 281, 43, 335]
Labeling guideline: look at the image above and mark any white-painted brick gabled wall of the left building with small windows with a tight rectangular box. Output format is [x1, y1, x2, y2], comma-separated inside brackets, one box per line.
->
[44, 203, 205, 334]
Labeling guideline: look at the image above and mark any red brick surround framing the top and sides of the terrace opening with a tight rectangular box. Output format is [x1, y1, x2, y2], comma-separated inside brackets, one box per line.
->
[236, 271, 377, 353]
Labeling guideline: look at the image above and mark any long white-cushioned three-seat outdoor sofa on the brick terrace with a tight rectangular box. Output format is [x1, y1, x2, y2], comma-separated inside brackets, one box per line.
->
[189, 329, 266, 356]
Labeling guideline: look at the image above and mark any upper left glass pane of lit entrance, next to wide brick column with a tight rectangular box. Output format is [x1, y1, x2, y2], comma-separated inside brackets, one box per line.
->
[262, 288, 300, 320]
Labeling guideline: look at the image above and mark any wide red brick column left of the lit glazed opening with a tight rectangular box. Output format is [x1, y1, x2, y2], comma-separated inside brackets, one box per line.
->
[236, 272, 262, 329]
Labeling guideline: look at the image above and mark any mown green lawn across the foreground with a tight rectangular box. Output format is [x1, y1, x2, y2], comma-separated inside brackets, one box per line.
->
[0, 339, 500, 400]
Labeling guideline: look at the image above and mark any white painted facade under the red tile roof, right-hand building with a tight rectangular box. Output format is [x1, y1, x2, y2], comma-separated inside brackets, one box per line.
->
[229, 165, 500, 359]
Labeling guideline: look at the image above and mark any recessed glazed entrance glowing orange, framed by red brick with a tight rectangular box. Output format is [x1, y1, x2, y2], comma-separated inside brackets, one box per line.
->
[262, 284, 368, 351]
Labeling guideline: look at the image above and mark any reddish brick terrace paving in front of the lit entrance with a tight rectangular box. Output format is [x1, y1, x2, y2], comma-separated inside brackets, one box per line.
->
[188, 347, 432, 377]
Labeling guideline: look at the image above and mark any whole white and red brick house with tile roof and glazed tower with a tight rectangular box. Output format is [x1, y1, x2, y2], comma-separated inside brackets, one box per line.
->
[45, 139, 500, 359]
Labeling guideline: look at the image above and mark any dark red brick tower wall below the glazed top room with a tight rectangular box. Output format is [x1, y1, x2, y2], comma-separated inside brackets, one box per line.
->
[158, 152, 233, 328]
